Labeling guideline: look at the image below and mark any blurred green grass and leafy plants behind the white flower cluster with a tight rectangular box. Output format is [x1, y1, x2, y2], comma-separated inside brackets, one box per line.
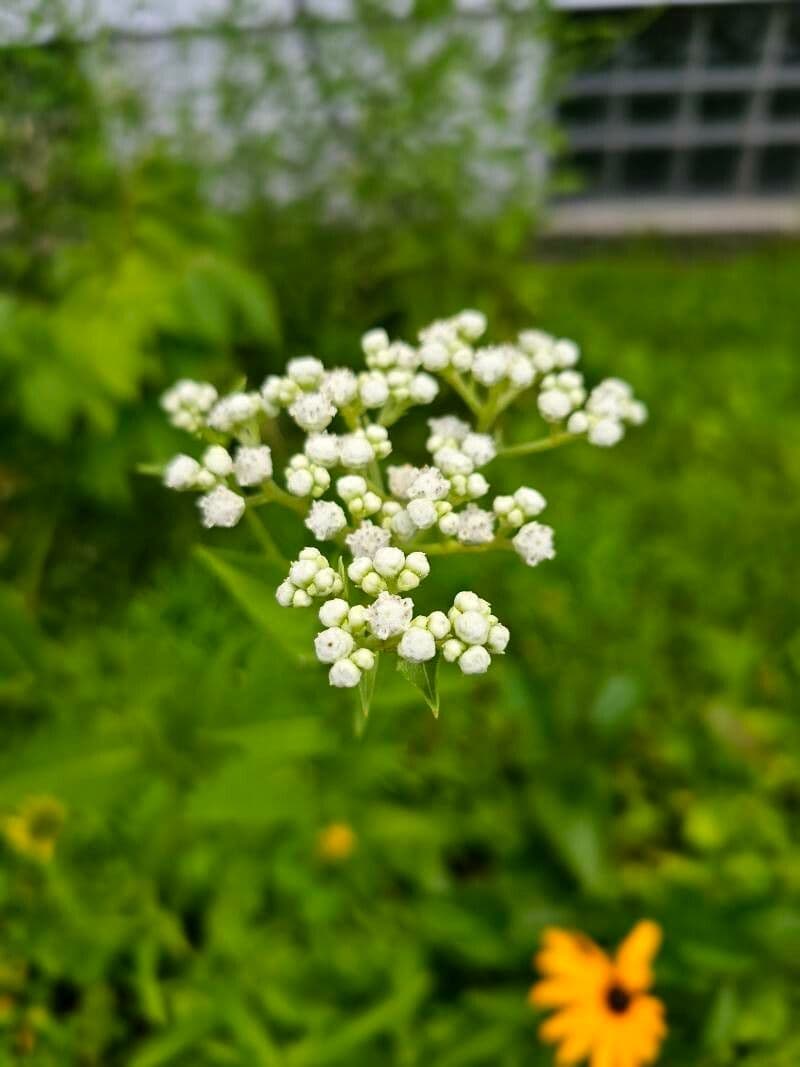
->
[0, 10, 800, 1067]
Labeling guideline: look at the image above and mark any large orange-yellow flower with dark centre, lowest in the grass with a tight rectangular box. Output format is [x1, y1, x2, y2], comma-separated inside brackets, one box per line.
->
[529, 921, 667, 1067]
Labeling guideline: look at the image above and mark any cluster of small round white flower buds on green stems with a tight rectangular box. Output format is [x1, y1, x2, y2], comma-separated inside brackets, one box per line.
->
[154, 310, 646, 688]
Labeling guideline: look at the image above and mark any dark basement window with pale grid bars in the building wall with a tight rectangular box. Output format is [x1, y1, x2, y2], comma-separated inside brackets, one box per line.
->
[561, 0, 800, 198]
